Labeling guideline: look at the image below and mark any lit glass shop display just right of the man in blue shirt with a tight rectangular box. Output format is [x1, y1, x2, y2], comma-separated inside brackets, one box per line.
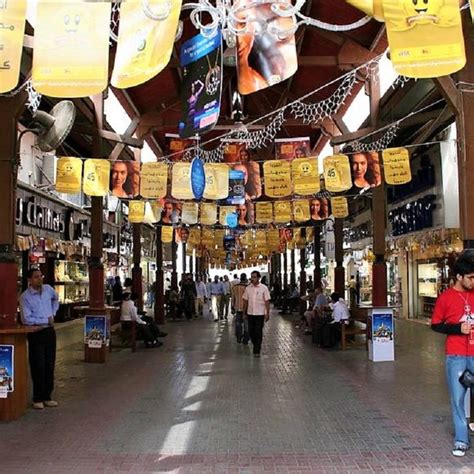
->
[54, 260, 89, 304]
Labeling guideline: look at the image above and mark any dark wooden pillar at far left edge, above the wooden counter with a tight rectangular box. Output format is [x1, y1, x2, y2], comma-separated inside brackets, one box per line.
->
[0, 91, 28, 328]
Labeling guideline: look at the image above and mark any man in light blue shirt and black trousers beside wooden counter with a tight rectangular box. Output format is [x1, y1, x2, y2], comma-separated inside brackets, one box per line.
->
[20, 268, 59, 410]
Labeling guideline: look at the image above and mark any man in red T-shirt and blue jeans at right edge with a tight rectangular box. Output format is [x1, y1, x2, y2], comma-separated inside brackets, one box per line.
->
[431, 250, 474, 457]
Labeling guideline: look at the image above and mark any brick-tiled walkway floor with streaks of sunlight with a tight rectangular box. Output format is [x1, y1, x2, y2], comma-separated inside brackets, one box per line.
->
[0, 314, 474, 473]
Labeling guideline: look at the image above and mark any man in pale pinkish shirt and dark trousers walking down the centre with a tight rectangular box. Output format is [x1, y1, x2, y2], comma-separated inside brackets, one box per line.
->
[242, 271, 270, 357]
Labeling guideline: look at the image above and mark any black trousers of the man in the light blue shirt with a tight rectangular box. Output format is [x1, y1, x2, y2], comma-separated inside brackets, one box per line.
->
[28, 327, 56, 403]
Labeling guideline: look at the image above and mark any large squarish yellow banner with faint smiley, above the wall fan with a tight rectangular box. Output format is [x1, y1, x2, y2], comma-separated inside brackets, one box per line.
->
[32, 0, 111, 98]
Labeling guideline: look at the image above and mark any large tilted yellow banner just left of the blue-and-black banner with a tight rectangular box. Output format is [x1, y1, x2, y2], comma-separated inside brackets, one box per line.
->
[111, 0, 181, 89]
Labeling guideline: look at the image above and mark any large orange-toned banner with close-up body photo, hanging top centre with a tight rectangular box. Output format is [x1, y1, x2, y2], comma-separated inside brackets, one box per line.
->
[235, 0, 298, 95]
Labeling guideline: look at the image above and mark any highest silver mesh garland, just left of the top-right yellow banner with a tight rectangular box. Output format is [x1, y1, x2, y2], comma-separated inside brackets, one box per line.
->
[290, 71, 356, 125]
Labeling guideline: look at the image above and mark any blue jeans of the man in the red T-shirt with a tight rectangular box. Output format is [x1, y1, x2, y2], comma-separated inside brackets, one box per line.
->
[446, 355, 474, 447]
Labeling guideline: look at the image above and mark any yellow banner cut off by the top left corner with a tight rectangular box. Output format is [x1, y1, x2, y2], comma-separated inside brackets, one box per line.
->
[0, 0, 26, 94]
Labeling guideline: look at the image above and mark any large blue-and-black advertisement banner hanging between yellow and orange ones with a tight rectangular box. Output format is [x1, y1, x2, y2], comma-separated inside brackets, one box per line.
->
[179, 29, 222, 138]
